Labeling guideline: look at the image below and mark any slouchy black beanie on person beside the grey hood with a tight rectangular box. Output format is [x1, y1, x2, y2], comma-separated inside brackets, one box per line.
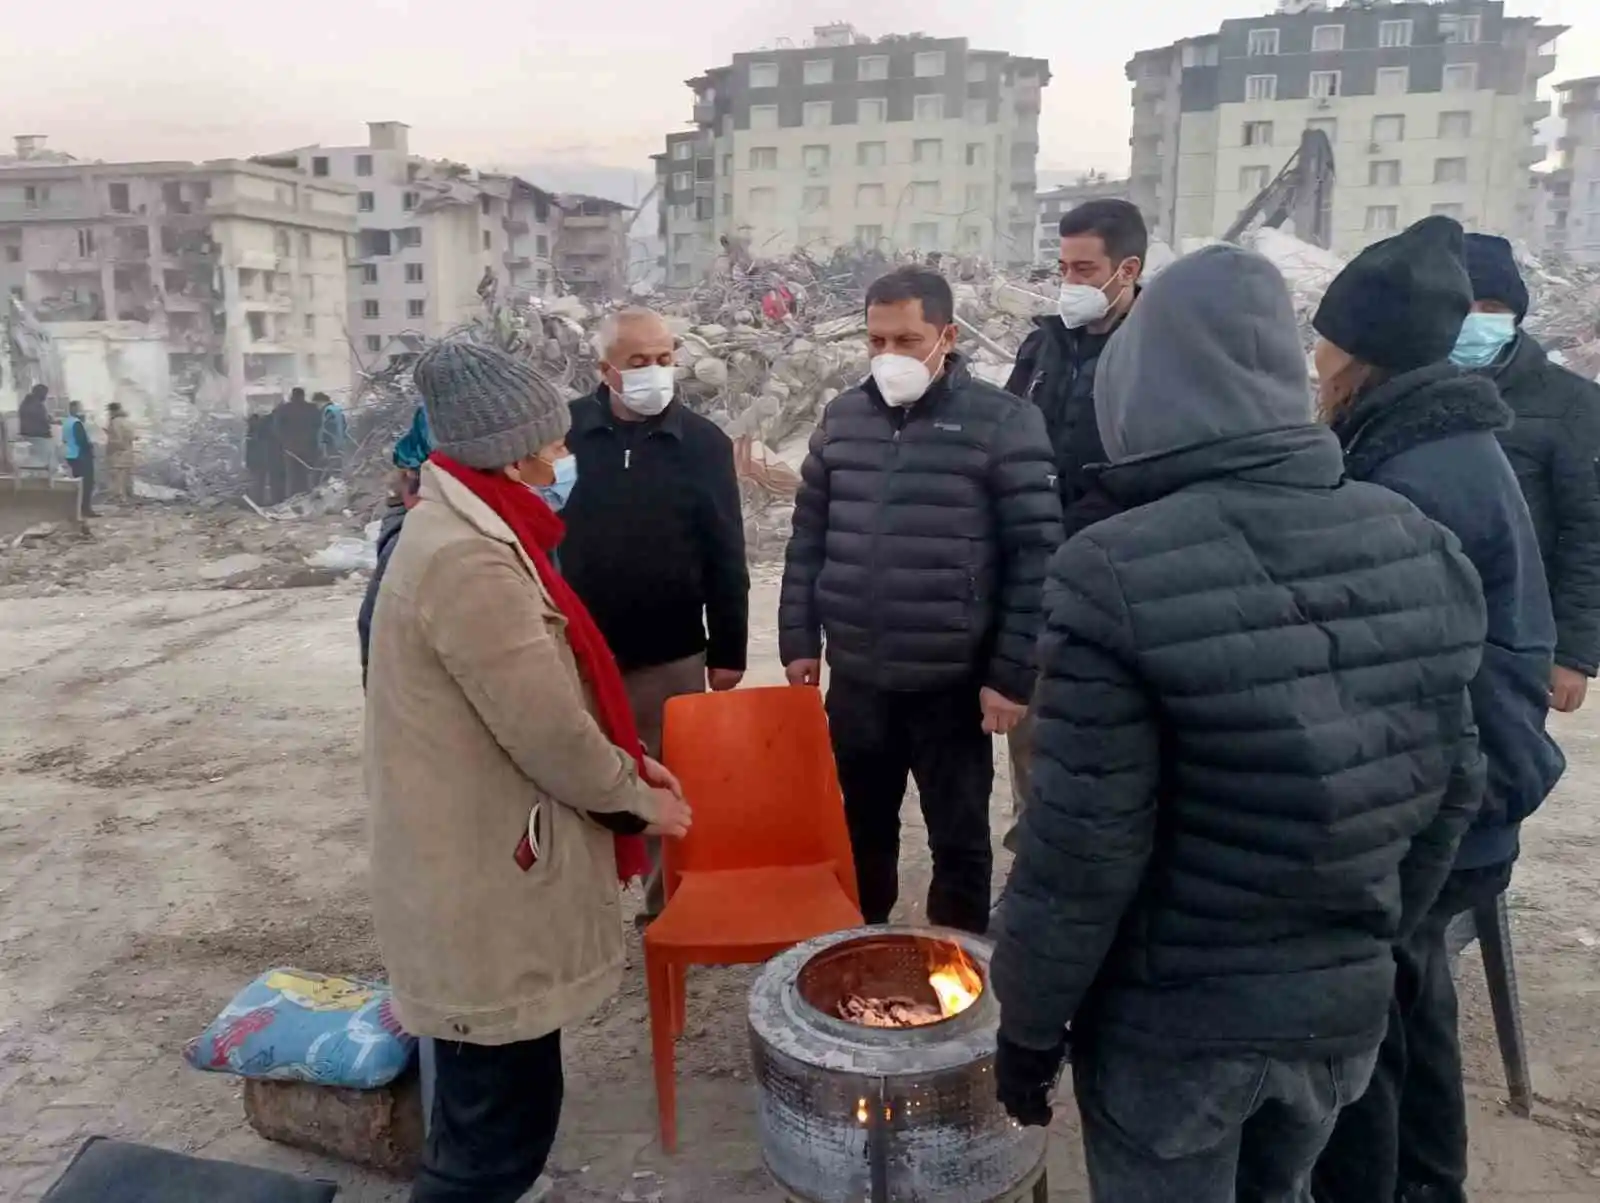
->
[1312, 218, 1472, 373]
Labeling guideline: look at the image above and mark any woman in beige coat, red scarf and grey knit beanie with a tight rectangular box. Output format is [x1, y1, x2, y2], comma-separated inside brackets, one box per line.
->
[366, 341, 690, 1203]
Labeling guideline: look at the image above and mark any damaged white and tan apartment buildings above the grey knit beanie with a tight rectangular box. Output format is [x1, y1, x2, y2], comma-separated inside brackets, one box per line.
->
[258, 122, 632, 368]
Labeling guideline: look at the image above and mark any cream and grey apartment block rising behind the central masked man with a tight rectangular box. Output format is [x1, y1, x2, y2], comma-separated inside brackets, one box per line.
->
[654, 26, 1050, 285]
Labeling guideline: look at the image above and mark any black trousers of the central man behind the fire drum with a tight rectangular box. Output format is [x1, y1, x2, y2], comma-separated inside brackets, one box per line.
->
[827, 675, 995, 936]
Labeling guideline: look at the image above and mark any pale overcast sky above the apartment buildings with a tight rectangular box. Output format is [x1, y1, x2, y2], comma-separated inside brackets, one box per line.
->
[0, 0, 1600, 183]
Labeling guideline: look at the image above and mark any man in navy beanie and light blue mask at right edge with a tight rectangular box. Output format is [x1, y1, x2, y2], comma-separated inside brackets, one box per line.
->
[1451, 234, 1600, 713]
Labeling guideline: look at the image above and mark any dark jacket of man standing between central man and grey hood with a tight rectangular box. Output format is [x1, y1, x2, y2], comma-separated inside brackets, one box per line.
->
[1005, 317, 1117, 539]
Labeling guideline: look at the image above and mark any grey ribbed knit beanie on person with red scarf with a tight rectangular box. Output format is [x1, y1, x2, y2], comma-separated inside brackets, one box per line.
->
[413, 339, 573, 470]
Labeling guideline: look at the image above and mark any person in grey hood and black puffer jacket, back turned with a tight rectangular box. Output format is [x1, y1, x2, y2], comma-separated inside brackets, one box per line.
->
[992, 246, 1485, 1203]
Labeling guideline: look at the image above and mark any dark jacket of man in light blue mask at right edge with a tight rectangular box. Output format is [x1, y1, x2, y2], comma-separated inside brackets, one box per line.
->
[1490, 334, 1600, 677]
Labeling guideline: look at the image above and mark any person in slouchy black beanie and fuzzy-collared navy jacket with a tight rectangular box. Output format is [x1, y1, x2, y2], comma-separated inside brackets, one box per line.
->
[1315, 218, 1566, 1203]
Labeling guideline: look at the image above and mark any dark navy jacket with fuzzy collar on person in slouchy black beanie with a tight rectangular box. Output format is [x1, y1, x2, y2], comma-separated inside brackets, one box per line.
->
[1333, 363, 1566, 869]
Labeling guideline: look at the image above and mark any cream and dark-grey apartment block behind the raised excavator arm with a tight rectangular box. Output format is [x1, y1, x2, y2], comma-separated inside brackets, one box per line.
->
[1128, 0, 1565, 254]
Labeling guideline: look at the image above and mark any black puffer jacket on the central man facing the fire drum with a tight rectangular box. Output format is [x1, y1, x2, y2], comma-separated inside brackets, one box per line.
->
[778, 355, 1061, 702]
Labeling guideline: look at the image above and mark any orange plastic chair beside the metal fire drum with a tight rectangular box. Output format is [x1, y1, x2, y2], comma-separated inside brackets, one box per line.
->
[645, 686, 862, 1153]
